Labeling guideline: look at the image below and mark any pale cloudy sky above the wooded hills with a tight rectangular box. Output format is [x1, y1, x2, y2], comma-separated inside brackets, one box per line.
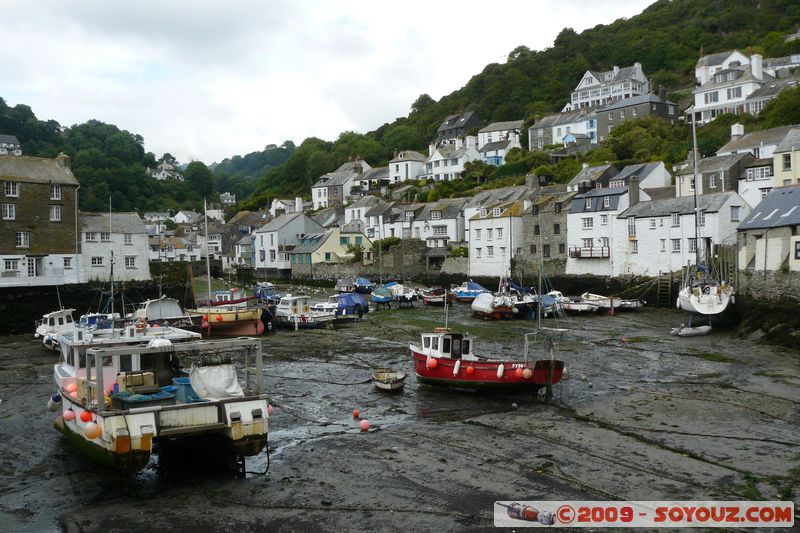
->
[0, 0, 653, 163]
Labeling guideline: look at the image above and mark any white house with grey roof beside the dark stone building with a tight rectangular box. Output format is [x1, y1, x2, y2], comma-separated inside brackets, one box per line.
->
[80, 213, 150, 281]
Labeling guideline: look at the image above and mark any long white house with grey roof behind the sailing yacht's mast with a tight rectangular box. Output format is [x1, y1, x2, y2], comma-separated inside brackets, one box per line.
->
[611, 191, 750, 276]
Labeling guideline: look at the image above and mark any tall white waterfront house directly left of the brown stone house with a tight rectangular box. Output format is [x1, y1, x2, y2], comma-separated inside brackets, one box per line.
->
[469, 200, 527, 277]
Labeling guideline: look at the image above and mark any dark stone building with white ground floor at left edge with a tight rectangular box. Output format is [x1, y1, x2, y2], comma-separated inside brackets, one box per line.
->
[0, 154, 83, 287]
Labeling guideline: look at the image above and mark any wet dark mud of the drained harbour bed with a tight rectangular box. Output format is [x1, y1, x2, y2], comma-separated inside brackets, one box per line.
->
[0, 305, 800, 531]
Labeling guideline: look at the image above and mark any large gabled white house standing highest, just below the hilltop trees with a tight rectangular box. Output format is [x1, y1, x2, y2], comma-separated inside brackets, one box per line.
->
[563, 63, 650, 111]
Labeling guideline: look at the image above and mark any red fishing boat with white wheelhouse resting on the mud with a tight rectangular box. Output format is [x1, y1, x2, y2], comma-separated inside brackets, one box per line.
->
[409, 328, 564, 391]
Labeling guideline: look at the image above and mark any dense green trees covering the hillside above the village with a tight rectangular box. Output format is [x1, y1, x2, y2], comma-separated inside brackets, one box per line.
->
[0, 0, 800, 211]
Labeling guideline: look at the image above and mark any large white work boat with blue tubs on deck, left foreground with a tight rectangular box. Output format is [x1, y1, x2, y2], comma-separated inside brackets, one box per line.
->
[48, 334, 268, 474]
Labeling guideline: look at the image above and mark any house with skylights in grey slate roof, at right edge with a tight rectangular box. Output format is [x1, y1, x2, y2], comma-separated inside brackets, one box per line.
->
[738, 185, 800, 272]
